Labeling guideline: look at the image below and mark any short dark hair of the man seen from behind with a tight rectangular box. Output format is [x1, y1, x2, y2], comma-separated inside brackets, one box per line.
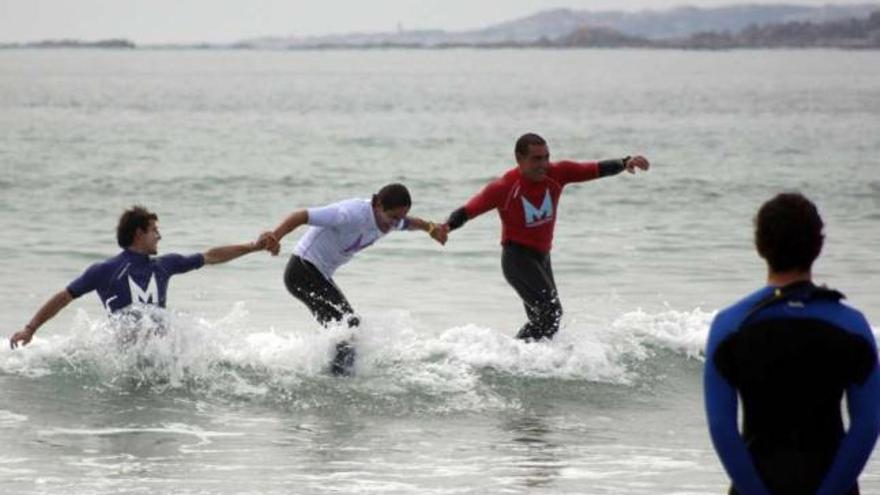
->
[755, 192, 825, 273]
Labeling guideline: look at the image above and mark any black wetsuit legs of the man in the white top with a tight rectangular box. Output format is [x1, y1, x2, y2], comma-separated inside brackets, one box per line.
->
[284, 255, 360, 375]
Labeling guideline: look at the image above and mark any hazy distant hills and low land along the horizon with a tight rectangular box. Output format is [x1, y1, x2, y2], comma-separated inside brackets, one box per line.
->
[0, 3, 880, 50]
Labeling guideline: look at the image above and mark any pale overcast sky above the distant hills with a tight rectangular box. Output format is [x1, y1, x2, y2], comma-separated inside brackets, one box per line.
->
[0, 0, 868, 43]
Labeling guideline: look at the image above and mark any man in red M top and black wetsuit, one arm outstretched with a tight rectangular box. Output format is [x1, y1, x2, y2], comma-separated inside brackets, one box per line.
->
[442, 134, 649, 341]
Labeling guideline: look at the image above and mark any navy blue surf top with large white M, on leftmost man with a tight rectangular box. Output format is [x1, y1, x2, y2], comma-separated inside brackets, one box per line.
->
[67, 250, 205, 313]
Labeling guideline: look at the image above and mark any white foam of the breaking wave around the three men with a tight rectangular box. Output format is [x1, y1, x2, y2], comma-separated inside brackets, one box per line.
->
[0, 303, 712, 411]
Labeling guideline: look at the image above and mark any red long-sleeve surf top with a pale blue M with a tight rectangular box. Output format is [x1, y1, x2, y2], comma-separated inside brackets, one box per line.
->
[464, 161, 599, 254]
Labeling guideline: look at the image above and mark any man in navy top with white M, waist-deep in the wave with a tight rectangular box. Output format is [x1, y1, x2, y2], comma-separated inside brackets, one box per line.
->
[9, 206, 268, 349]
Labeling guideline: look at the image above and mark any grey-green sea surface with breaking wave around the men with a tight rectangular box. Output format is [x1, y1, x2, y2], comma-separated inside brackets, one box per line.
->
[0, 50, 880, 494]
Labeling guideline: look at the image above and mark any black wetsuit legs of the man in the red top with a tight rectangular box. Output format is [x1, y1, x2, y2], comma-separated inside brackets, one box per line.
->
[501, 242, 562, 340]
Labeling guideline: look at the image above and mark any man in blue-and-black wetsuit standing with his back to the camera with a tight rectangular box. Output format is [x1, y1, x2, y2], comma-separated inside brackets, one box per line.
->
[704, 193, 880, 495]
